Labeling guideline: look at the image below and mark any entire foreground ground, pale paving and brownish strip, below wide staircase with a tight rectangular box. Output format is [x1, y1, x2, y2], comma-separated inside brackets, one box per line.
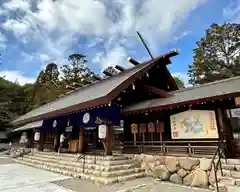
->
[0, 156, 212, 192]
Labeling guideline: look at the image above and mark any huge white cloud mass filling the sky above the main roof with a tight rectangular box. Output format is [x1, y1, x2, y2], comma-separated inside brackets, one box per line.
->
[0, 0, 207, 71]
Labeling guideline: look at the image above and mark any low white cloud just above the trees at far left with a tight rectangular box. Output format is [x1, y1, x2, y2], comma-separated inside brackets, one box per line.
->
[0, 71, 35, 85]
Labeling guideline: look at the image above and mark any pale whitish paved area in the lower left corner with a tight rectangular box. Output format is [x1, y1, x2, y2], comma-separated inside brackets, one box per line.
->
[0, 157, 71, 192]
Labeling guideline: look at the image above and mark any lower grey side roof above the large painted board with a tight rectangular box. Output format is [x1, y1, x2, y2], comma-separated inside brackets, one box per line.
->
[123, 76, 240, 112]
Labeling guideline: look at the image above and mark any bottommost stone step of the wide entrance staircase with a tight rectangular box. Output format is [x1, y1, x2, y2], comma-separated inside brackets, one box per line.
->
[14, 159, 145, 184]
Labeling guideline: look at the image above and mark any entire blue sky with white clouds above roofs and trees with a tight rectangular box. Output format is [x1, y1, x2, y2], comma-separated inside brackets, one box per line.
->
[0, 0, 240, 85]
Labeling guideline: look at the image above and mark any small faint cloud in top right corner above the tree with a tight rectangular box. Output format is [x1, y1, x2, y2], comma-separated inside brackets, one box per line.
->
[223, 0, 240, 23]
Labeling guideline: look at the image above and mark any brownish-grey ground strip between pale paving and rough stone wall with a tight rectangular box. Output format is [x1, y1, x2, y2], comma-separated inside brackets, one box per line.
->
[53, 178, 210, 192]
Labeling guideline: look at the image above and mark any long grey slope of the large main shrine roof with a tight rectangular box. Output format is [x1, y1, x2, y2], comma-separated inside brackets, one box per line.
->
[13, 51, 176, 124]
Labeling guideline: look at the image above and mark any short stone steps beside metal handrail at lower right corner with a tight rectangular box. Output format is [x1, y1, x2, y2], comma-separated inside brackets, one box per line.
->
[217, 159, 240, 192]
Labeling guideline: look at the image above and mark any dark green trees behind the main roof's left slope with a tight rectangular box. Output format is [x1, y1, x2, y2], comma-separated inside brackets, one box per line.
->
[0, 54, 97, 129]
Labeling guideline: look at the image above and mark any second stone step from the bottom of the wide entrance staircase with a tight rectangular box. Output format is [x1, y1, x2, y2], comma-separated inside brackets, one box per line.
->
[22, 157, 144, 177]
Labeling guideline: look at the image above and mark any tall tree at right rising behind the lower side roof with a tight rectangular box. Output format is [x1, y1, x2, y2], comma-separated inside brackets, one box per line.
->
[188, 23, 240, 84]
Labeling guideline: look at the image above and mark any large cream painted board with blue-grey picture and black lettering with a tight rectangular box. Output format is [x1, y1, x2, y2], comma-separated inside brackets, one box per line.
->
[170, 110, 219, 139]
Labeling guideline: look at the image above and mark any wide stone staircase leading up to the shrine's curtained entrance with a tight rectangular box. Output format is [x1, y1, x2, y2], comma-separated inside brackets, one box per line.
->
[14, 151, 145, 184]
